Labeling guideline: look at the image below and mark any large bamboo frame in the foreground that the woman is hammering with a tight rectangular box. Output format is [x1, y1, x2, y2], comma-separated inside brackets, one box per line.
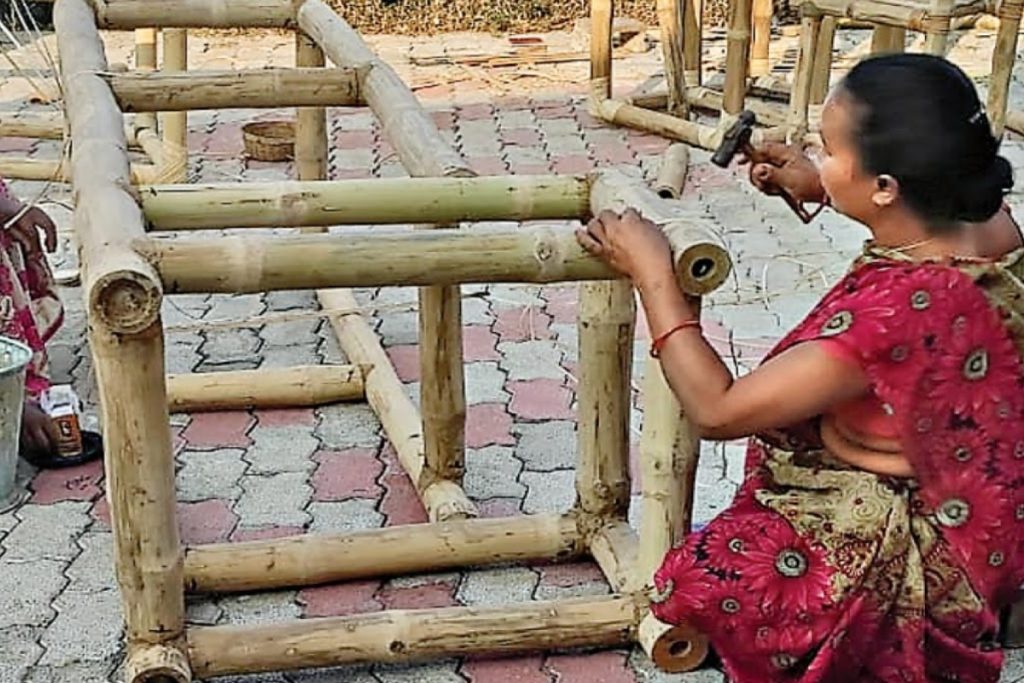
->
[54, 0, 731, 683]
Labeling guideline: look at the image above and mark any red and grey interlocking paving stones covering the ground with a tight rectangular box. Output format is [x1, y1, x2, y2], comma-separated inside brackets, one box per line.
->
[0, 22, 1024, 683]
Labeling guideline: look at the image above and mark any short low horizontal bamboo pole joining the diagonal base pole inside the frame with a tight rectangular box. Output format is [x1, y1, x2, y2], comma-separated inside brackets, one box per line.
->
[167, 366, 365, 413]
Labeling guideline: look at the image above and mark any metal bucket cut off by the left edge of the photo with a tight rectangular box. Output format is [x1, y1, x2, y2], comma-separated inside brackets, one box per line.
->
[0, 337, 32, 512]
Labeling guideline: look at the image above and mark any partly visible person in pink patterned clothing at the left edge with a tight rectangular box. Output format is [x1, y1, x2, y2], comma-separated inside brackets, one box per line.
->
[0, 180, 63, 464]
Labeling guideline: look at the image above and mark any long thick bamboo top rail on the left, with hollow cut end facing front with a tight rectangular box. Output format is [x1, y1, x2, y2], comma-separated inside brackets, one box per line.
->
[55, 0, 163, 335]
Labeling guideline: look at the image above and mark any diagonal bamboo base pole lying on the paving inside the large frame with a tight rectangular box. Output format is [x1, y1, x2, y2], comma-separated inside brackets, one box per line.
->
[317, 286, 476, 521]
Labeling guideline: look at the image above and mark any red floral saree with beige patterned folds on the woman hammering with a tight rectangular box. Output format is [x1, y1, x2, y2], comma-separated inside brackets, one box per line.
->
[652, 248, 1024, 683]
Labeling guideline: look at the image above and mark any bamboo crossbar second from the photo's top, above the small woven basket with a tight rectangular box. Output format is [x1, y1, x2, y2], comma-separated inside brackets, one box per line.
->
[105, 68, 360, 112]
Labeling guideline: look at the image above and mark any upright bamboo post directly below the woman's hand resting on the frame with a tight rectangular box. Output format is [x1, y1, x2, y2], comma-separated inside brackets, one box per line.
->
[577, 280, 636, 520]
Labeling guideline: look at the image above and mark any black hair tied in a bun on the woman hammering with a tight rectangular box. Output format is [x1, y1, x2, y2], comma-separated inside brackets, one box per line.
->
[840, 54, 1014, 230]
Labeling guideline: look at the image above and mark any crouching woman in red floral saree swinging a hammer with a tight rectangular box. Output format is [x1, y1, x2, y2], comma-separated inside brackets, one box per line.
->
[579, 54, 1024, 683]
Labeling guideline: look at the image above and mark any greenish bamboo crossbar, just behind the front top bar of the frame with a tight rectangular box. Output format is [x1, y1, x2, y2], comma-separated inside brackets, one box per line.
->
[141, 175, 590, 230]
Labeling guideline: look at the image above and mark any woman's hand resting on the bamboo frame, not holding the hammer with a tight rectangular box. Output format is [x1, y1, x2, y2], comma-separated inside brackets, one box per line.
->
[577, 209, 674, 290]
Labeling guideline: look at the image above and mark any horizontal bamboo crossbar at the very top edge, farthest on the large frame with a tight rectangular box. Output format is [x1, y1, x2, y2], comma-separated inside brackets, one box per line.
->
[90, 0, 295, 31]
